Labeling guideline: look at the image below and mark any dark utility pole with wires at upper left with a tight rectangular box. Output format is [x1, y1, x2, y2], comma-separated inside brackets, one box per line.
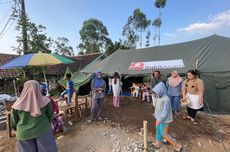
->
[19, 0, 28, 54]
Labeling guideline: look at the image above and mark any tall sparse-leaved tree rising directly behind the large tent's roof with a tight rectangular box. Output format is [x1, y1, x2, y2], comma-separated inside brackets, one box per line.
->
[122, 9, 151, 47]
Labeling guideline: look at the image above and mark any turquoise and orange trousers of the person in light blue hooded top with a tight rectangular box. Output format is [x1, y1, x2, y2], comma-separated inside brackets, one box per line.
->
[156, 123, 176, 144]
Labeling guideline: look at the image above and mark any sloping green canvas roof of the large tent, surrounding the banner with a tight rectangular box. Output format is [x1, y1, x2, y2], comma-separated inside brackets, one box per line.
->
[82, 35, 230, 75]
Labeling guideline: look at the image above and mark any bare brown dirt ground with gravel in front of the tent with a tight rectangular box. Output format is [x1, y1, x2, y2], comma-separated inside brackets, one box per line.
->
[0, 97, 230, 152]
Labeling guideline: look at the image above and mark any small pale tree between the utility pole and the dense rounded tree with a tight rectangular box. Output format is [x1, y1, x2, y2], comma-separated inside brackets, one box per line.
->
[54, 37, 74, 56]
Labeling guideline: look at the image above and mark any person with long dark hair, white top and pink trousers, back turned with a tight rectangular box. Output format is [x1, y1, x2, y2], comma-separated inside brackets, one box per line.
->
[112, 72, 121, 108]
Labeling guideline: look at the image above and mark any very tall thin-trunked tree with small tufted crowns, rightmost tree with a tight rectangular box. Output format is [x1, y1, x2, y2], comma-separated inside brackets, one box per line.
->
[152, 0, 167, 45]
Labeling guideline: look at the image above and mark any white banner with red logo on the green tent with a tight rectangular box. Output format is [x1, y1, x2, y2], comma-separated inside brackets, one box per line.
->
[129, 59, 185, 70]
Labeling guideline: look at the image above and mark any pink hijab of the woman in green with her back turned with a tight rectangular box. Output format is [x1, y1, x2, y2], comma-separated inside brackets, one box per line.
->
[12, 80, 50, 117]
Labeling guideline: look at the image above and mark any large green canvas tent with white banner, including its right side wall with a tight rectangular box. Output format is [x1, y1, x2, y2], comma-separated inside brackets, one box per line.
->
[82, 35, 230, 112]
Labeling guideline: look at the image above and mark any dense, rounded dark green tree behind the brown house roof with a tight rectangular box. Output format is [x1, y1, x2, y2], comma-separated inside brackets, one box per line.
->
[78, 18, 111, 54]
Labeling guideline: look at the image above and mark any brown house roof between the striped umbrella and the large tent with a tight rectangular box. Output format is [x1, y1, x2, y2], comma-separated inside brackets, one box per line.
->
[46, 53, 102, 75]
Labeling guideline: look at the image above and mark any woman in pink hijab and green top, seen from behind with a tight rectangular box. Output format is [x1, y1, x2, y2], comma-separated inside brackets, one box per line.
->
[11, 80, 57, 152]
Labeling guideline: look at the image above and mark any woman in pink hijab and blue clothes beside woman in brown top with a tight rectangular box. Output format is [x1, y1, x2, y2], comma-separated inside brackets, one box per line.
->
[166, 71, 183, 114]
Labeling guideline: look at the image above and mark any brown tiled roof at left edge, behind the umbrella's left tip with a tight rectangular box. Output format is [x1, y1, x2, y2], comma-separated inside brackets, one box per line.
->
[0, 53, 22, 79]
